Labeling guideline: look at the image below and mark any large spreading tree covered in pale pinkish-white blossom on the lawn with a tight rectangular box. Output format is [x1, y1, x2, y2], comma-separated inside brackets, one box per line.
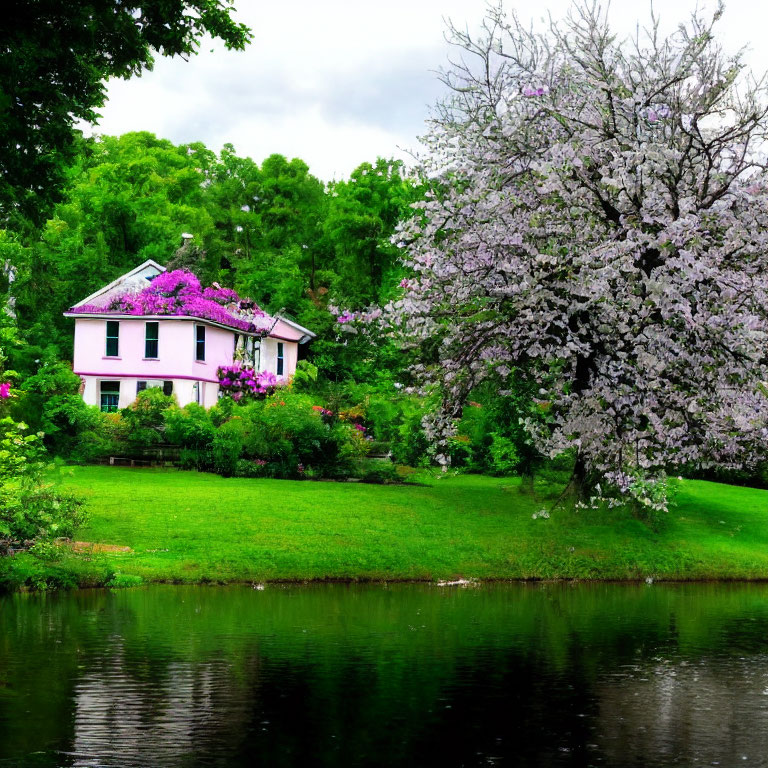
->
[392, 4, 768, 508]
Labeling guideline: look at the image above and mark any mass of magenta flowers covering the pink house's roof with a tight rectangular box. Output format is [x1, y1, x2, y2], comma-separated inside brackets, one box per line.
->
[73, 269, 272, 333]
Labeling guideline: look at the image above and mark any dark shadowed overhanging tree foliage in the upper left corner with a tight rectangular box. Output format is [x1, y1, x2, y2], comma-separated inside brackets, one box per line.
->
[0, 0, 250, 226]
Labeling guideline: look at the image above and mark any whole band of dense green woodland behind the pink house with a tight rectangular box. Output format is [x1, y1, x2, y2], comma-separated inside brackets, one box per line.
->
[0, 133, 417, 380]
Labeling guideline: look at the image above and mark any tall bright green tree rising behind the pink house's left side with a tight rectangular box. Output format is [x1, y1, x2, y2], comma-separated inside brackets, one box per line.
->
[10, 133, 216, 371]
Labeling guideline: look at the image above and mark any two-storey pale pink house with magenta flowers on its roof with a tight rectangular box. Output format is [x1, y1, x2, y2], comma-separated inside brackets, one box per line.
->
[64, 260, 315, 411]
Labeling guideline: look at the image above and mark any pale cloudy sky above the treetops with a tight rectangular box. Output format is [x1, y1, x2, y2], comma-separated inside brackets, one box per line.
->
[82, 0, 768, 181]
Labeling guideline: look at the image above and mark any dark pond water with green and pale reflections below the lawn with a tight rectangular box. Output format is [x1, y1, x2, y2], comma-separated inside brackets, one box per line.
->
[0, 585, 768, 768]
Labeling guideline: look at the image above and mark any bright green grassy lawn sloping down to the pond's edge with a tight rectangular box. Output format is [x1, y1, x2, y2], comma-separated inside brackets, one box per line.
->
[0, 467, 768, 587]
